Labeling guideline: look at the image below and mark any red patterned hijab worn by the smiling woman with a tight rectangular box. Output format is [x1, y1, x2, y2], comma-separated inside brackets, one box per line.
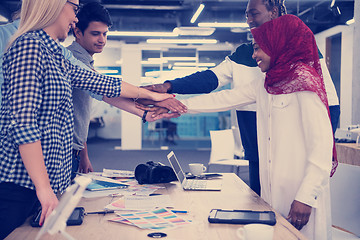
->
[251, 14, 338, 176]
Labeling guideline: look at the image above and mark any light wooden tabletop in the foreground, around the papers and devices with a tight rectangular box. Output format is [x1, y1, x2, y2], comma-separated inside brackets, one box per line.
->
[6, 173, 306, 240]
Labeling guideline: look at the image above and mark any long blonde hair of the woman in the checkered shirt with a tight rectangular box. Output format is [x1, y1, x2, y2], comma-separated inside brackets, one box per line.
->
[8, 0, 66, 47]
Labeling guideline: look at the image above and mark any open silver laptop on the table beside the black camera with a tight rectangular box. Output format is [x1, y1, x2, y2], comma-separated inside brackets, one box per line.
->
[167, 151, 222, 191]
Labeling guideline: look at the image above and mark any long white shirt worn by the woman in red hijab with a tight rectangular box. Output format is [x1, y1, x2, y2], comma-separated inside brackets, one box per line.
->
[182, 78, 333, 239]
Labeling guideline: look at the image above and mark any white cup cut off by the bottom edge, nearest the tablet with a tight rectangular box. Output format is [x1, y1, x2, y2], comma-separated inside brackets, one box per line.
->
[236, 224, 274, 240]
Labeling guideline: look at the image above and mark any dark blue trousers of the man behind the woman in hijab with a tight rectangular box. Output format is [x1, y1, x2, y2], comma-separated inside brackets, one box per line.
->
[236, 111, 260, 196]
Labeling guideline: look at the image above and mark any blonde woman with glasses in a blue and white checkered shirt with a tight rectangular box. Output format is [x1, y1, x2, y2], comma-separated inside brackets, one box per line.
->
[0, 0, 172, 239]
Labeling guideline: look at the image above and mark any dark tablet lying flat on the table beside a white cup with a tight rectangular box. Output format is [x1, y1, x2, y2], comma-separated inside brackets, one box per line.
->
[208, 209, 276, 225]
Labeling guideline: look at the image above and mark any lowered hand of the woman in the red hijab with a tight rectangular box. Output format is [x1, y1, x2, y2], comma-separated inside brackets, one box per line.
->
[286, 200, 312, 230]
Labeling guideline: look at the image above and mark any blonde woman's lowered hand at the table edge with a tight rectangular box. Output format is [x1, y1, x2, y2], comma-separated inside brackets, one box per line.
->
[36, 186, 59, 226]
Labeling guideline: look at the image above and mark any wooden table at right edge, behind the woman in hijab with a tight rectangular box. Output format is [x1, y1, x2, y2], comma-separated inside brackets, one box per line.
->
[336, 143, 360, 166]
